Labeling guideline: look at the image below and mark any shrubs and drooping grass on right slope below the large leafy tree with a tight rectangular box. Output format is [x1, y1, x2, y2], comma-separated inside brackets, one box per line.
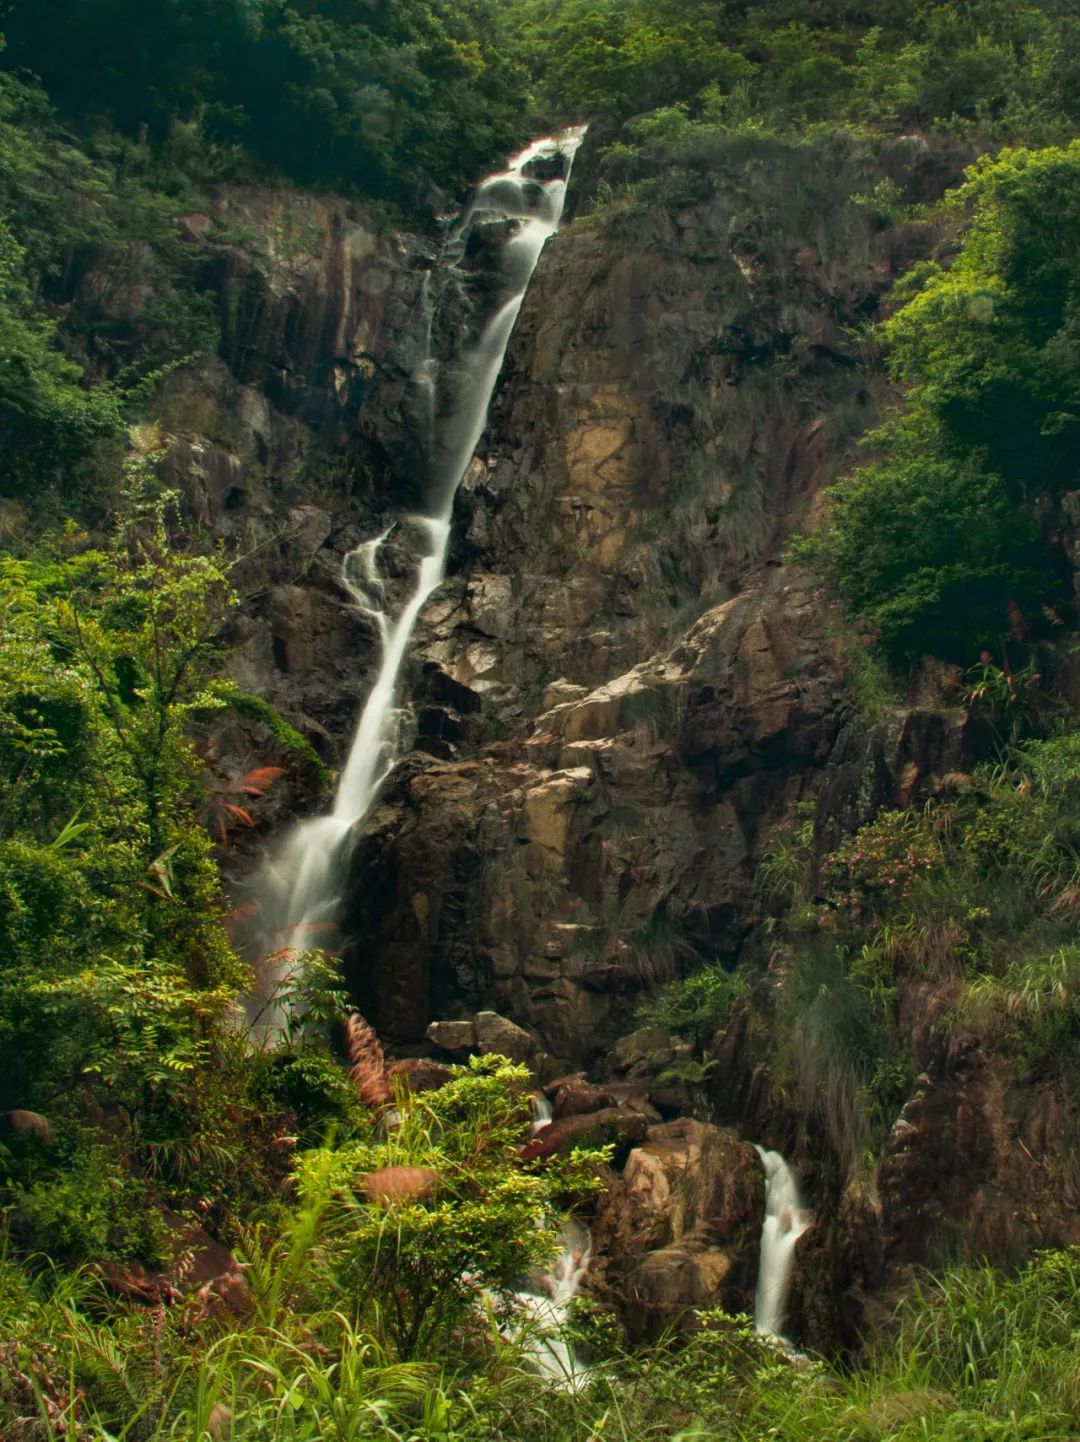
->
[755, 731, 1080, 1168]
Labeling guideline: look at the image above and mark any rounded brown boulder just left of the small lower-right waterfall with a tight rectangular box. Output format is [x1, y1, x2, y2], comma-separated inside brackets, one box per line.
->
[590, 1119, 764, 1337]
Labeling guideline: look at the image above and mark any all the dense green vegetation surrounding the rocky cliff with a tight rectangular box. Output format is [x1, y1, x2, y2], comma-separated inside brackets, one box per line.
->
[0, 0, 1080, 1442]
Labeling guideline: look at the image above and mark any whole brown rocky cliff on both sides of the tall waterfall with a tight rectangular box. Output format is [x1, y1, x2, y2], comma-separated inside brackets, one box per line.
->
[139, 137, 1076, 1344]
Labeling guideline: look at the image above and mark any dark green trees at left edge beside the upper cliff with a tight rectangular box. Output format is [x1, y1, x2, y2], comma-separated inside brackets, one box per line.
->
[0, 71, 218, 521]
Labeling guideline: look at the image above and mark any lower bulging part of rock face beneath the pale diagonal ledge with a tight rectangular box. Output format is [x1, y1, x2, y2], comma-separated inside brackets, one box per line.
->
[348, 568, 842, 1061]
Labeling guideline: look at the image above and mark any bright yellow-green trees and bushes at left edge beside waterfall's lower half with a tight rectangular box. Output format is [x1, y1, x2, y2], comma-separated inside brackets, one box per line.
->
[0, 457, 298, 1256]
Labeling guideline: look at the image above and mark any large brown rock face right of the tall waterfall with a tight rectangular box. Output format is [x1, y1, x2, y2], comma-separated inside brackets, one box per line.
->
[334, 143, 959, 1066]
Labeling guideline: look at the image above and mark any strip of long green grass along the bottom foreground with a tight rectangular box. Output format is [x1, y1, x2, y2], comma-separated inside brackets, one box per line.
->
[0, 1239, 1080, 1442]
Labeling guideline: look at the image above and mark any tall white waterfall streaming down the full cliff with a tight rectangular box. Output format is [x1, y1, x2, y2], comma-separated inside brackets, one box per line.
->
[248, 127, 585, 1031]
